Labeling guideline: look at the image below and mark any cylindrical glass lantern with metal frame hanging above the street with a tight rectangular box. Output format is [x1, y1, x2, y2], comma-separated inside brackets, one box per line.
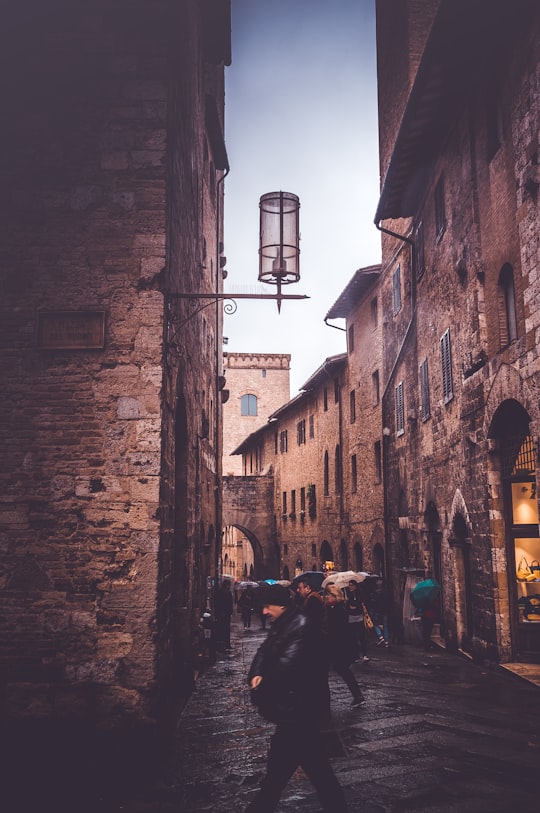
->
[259, 192, 300, 286]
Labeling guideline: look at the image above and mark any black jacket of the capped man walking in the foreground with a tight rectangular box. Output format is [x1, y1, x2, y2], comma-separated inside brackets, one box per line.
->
[248, 605, 330, 723]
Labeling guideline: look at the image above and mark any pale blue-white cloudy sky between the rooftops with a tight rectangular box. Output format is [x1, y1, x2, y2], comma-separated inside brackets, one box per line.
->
[224, 0, 380, 396]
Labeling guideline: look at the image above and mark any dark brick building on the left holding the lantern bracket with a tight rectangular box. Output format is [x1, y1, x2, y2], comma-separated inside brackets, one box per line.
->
[0, 0, 230, 737]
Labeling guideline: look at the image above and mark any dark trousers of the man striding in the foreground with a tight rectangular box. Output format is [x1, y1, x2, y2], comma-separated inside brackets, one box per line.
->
[246, 722, 347, 813]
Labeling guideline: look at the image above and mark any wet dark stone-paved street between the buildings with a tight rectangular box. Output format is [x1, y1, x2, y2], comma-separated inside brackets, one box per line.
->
[113, 616, 540, 813]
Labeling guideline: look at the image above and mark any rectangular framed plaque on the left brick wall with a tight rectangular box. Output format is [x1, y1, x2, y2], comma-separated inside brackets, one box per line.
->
[37, 311, 105, 350]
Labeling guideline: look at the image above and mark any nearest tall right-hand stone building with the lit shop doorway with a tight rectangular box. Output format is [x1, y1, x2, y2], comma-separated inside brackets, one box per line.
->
[376, 0, 540, 661]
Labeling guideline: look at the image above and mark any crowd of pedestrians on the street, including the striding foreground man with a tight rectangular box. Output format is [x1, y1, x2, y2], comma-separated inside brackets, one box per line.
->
[208, 573, 433, 813]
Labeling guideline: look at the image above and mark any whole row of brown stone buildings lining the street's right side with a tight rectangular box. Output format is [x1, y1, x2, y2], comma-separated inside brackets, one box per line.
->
[226, 0, 540, 661]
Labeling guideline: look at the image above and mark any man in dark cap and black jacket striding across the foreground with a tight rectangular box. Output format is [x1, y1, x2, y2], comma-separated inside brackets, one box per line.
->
[246, 584, 347, 813]
